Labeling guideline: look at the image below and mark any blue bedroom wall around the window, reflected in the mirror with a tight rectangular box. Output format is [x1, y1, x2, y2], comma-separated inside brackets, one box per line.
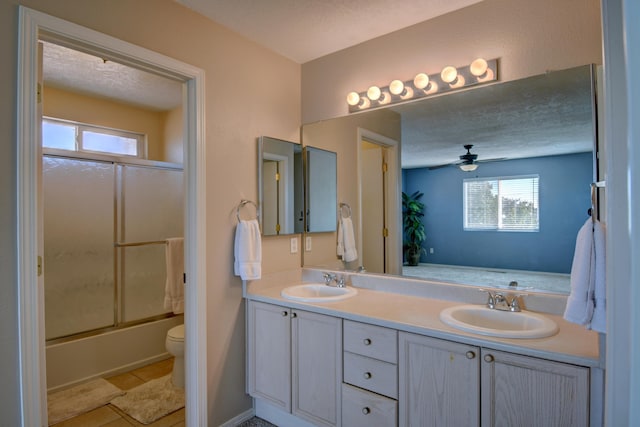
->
[402, 153, 593, 273]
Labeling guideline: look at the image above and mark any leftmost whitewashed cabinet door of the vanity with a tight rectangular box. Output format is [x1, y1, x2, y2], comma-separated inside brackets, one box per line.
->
[247, 301, 291, 412]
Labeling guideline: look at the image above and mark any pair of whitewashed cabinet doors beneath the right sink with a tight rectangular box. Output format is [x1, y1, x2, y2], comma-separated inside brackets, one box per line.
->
[399, 332, 589, 427]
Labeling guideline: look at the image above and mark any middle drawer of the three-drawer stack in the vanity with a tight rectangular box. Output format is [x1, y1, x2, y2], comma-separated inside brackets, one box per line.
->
[344, 352, 398, 399]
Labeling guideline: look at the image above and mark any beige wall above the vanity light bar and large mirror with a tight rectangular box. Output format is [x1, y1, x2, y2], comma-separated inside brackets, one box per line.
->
[302, 0, 602, 123]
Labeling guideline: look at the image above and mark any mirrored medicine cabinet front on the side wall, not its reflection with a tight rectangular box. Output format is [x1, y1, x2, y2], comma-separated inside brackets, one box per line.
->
[258, 136, 304, 236]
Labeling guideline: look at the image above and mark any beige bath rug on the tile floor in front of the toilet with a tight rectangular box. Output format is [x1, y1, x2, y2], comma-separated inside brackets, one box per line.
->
[111, 374, 184, 424]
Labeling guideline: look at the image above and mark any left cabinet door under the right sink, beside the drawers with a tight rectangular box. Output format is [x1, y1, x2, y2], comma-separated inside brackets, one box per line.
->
[398, 332, 480, 427]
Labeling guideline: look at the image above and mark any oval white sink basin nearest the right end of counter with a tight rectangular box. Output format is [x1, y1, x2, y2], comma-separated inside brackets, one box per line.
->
[440, 305, 558, 338]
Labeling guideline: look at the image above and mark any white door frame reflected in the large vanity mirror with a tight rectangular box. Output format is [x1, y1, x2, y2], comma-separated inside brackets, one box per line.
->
[357, 127, 402, 274]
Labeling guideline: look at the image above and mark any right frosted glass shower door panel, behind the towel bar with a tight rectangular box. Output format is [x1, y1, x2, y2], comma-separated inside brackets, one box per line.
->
[119, 165, 184, 322]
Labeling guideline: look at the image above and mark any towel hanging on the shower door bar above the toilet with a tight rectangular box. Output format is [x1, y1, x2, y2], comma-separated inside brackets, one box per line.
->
[164, 237, 184, 314]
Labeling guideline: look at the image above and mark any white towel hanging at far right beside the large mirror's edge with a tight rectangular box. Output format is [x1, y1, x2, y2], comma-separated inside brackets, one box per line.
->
[564, 219, 606, 332]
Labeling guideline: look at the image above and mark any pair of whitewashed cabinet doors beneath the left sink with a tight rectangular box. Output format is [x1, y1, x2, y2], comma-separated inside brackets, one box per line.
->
[247, 301, 342, 426]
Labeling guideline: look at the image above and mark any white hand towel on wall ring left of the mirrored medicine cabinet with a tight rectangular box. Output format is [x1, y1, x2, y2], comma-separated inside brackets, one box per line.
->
[233, 219, 262, 280]
